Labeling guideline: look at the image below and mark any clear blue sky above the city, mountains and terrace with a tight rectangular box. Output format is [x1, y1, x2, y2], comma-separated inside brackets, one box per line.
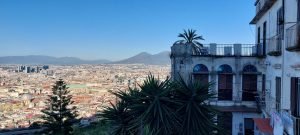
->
[0, 0, 255, 60]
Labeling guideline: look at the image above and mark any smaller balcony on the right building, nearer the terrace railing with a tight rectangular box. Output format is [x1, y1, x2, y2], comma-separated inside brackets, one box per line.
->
[268, 35, 282, 56]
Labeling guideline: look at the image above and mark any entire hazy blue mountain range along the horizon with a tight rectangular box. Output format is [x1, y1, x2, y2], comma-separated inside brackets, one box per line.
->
[0, 51, 171, 65]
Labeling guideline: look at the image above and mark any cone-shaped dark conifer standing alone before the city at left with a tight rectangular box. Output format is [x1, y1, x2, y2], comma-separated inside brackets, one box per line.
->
[42, 79, 77, 135]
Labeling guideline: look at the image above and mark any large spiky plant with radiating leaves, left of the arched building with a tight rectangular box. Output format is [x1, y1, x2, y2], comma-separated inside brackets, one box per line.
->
[112, 75, 179, 134]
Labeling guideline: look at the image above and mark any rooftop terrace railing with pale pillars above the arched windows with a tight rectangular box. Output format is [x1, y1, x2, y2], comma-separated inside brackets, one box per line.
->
[192, 44, 262, 57]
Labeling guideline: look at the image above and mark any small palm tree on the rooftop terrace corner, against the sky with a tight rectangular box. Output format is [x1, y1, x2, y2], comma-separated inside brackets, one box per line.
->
[176, 29, 204, 54]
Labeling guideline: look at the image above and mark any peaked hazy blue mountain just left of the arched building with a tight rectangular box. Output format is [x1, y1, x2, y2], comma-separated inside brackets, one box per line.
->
[112, 51, 171, 65]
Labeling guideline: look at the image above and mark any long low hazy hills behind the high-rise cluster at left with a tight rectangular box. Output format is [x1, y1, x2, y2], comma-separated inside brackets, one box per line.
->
[0, 55, 111, 65]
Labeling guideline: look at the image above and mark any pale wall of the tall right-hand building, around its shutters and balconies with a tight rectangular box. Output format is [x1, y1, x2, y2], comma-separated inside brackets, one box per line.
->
[256, 0, 300, 110]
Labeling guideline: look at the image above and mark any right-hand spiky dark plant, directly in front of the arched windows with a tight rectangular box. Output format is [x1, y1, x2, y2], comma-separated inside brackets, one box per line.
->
[174, 78, 221, 135]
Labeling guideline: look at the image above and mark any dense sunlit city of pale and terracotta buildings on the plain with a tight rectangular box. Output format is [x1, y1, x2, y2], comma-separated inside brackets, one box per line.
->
[0, 64, 170, 129]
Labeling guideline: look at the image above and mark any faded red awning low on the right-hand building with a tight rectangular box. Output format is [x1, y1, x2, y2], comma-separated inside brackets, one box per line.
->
[253, 118, 273, 134]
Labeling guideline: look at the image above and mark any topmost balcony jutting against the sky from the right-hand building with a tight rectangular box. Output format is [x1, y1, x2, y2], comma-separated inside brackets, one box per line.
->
[250, 0, 277, 24]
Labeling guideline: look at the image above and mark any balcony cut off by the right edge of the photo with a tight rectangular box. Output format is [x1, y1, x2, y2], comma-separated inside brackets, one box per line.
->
[286, 22, 300, 52]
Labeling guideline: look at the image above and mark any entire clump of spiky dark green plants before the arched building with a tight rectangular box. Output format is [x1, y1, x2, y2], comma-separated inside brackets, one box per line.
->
[101, 75, 224, 135]
